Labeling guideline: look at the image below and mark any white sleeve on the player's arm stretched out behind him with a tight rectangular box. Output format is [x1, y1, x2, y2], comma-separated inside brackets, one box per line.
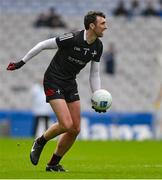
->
[22, 38, 58, 63]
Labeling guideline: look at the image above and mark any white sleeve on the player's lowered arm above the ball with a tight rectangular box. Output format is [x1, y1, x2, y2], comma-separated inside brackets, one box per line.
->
[89, 61, 101, 92]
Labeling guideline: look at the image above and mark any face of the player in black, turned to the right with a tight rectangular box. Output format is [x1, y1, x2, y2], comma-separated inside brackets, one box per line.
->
[93, 16, 107, 37]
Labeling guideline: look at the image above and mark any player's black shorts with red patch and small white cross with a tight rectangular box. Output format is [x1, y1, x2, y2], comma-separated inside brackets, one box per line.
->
[43, 78, 80, 102]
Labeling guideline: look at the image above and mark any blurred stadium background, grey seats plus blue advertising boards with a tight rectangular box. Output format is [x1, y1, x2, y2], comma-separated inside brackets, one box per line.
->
[0, 0, 162, 140]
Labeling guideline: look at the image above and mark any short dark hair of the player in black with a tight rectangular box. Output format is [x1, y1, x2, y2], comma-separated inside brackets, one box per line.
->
[84, 11, 106, 30]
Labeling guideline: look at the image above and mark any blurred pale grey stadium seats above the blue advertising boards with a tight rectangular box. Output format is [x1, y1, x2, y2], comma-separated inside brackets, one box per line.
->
[0, 0, 162, 112]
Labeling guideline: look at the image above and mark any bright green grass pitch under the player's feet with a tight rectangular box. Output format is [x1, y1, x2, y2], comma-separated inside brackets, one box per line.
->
[0, 139, 162, 179]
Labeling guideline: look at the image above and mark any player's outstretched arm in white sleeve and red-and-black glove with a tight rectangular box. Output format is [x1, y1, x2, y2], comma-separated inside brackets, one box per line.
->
[7, 38, 58, 71]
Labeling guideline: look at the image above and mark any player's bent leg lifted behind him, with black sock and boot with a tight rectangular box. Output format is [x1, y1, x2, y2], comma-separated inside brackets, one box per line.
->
[30, 99, 73, 165]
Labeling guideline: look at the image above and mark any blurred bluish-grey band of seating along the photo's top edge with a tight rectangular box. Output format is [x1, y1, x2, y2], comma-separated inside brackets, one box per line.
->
[0, 0, 159, 16]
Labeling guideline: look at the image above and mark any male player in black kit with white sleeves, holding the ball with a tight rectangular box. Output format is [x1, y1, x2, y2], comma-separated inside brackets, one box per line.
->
[7, 11, 107, 171]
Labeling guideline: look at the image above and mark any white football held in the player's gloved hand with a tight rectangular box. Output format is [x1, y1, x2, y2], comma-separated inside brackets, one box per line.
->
[91, 89, 112, 110]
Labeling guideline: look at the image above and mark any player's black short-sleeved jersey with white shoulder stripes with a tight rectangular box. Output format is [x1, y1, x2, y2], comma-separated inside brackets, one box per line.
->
[45, 30, 103, 80]
